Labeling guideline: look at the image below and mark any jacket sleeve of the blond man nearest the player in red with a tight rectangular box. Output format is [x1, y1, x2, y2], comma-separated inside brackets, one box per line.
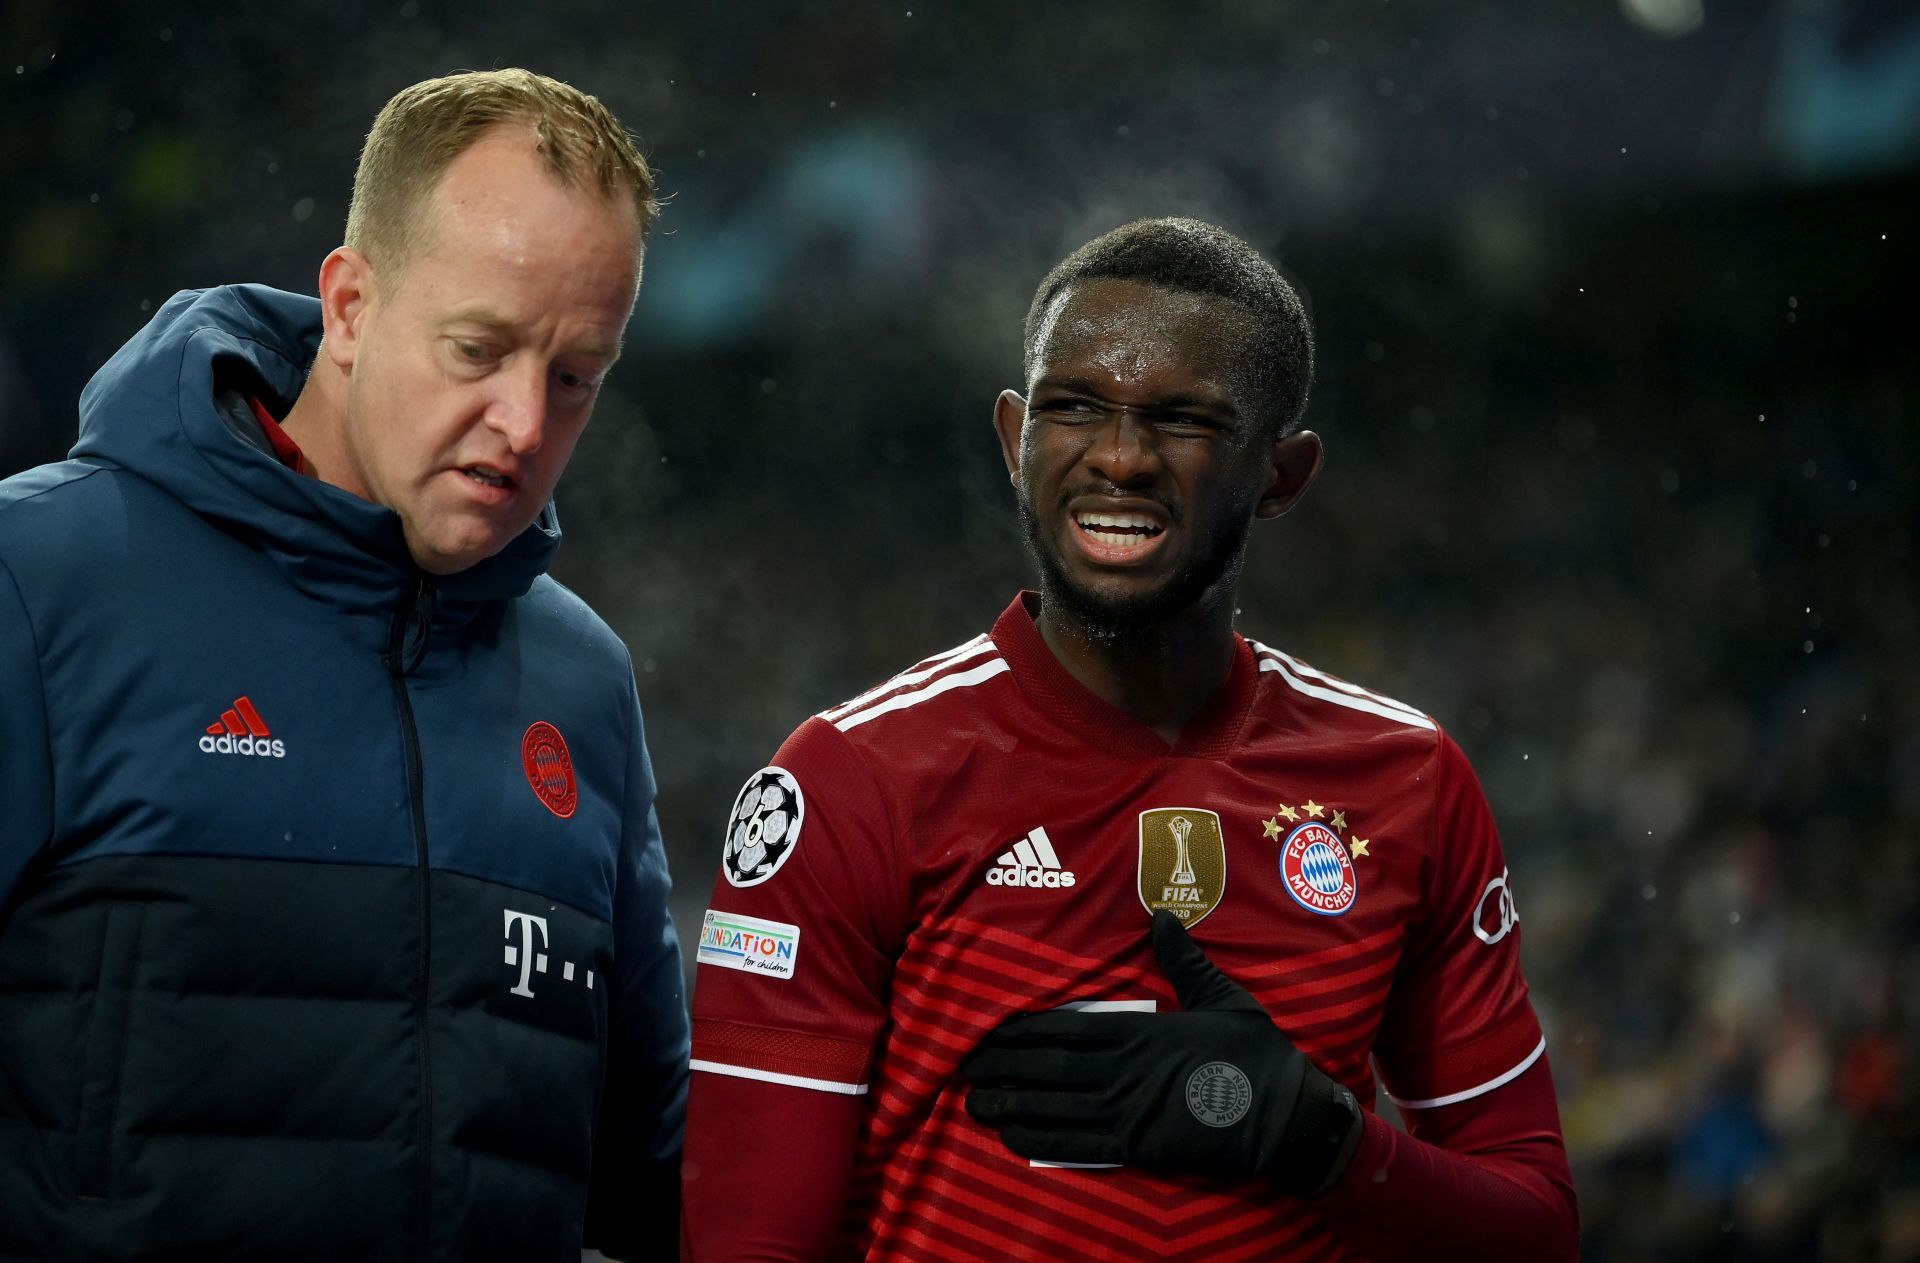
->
[586, 667, 687, 1259]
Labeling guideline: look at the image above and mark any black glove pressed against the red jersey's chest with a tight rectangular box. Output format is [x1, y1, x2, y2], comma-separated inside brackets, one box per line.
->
[960, 912, 1361, 1196]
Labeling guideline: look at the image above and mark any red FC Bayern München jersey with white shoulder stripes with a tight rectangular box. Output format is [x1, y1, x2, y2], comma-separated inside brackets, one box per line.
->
[693, 595, 1544, 1263]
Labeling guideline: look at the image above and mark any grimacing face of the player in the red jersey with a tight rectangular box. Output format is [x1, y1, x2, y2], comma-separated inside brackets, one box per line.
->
[996, 280, 1319, 637]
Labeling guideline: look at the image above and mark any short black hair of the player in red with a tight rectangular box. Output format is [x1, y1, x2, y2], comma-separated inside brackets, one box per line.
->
[1025, 219, 1313, 436]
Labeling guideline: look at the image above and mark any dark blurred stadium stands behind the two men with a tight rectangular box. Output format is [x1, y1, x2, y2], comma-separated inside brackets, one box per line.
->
[0, 0, 1920, 1261]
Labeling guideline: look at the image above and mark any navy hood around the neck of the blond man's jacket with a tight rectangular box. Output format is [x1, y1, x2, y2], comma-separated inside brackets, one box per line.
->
[71, 284, 561, 610]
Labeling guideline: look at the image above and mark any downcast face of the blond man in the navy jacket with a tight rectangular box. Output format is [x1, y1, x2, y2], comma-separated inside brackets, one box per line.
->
[323, 127, 639, 574]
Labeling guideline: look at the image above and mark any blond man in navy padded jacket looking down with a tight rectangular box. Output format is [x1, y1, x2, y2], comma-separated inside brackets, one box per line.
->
[0, 71, 687, 1259]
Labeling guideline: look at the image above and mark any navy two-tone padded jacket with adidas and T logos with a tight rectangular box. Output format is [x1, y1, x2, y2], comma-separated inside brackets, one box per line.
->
[0, 286, 687, 1261]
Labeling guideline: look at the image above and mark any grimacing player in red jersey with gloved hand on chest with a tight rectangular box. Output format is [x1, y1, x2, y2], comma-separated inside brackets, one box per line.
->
[684, 219, 1576, 1263]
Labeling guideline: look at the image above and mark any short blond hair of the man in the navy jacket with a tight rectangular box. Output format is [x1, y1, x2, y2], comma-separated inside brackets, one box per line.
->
[346, 69, 660, 274]
